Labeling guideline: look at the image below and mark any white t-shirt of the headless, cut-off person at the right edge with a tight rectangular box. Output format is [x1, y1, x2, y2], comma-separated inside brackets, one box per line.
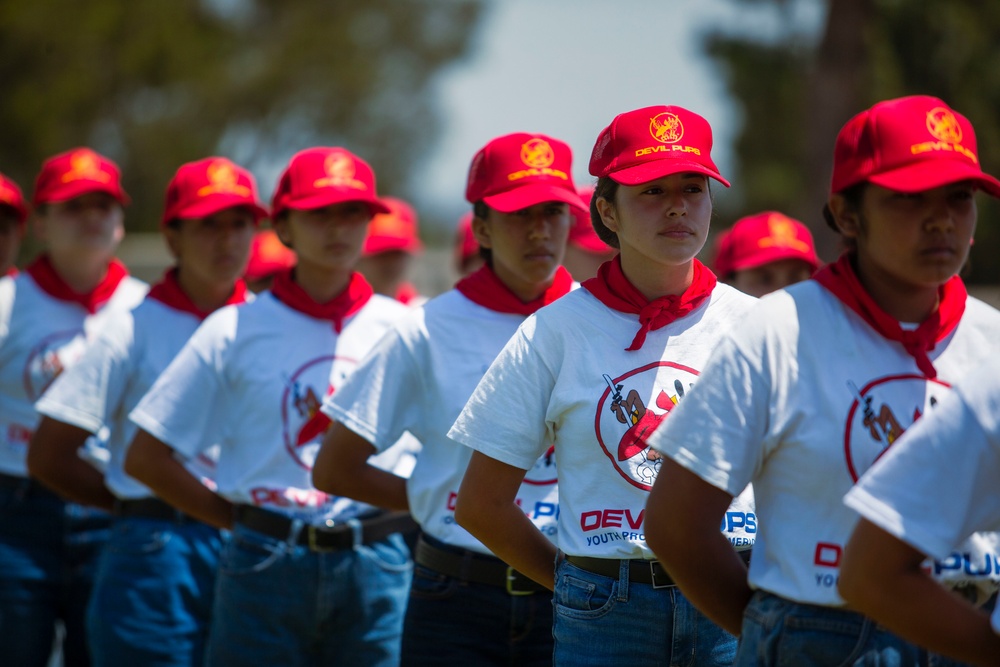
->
[844, 356, 1000, 616]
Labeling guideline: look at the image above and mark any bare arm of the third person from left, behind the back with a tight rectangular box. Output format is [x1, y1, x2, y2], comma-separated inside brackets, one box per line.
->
[125, 429, 233, 529]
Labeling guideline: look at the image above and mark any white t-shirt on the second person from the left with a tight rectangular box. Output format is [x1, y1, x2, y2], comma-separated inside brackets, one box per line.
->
[35, 298, 237, 500]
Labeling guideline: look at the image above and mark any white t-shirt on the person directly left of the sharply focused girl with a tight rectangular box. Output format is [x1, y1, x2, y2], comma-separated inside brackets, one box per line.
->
[323, 290, 559, 554]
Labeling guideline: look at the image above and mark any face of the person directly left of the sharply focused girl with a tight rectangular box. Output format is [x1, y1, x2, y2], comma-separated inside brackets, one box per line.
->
[472, 201, 572, 292]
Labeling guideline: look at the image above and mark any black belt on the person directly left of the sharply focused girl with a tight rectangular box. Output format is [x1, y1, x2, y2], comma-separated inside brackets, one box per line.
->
[413, 535, 548, 595]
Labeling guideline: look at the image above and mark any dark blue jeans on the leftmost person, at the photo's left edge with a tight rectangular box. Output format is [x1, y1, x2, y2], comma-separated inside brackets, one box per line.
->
[0, 475, 111, 667]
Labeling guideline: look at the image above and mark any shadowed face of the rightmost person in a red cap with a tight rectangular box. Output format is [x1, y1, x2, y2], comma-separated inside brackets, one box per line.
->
[831, 182, 977, 288]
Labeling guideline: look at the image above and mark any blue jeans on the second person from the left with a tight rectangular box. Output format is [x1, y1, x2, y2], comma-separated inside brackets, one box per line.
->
[87, 517, 222, 667]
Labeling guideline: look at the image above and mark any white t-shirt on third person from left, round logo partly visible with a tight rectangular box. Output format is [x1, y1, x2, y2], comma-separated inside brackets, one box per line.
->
[130, 292, 408, 525]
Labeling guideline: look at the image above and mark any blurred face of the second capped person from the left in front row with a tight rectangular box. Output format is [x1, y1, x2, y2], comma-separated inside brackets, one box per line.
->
[163, 206, 256, 284]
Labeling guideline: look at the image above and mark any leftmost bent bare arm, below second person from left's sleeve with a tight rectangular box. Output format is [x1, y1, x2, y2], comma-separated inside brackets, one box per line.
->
[28, 416, 115, 511]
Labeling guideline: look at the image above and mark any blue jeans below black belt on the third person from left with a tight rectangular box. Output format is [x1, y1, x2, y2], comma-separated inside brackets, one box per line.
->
[208, 523, 413, 667]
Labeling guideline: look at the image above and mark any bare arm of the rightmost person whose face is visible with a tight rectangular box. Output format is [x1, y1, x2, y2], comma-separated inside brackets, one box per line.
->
[644, 459, 752, 636]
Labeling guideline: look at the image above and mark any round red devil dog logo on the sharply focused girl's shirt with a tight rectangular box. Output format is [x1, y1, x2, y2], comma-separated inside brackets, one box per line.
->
[595, 361, 698, 491]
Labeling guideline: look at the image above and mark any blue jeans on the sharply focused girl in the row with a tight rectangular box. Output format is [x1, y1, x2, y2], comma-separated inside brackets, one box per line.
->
[553, 559, 736, 667]
